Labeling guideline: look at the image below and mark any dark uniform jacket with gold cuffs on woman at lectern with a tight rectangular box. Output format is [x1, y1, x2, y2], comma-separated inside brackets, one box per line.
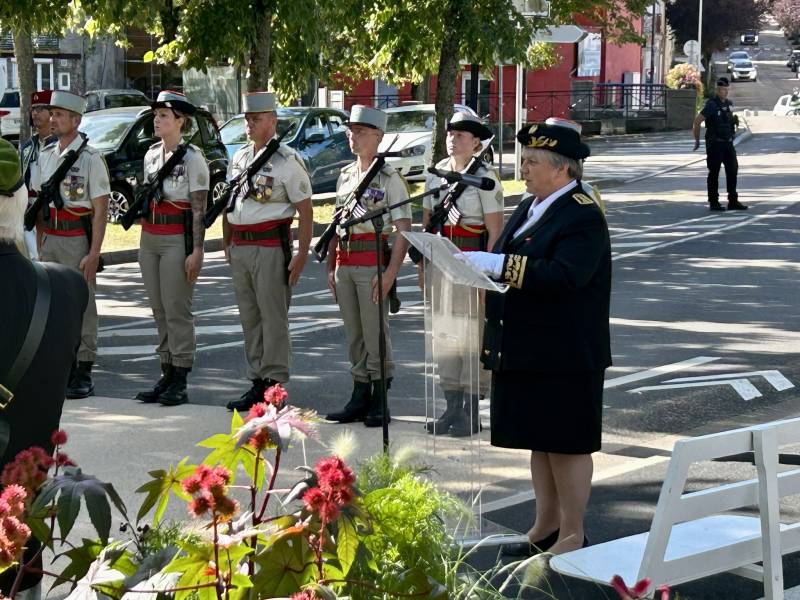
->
[481, 186, 611, 373]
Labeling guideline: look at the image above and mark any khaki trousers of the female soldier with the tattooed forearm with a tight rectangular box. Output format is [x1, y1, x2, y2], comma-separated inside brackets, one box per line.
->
[139, 231, 196, 369]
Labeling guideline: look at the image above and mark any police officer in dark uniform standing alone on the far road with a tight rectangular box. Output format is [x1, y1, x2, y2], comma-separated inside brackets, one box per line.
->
[692, 77, 747, 210]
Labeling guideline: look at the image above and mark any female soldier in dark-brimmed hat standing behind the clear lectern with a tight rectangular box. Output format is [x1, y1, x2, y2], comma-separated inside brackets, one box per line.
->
[419, 113, 503, 436]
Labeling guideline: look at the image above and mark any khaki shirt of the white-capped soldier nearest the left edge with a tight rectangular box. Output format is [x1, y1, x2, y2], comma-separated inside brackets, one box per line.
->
[31, 135, 111, 208]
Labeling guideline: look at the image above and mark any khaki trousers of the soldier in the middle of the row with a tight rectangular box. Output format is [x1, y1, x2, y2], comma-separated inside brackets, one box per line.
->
[230, 245, 292, 383]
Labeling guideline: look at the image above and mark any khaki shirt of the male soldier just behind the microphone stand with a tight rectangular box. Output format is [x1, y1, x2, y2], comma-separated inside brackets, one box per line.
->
[336, 162, 411, 234]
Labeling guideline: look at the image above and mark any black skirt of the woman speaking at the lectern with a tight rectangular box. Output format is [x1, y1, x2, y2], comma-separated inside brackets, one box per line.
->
[490, 370, 604, 454]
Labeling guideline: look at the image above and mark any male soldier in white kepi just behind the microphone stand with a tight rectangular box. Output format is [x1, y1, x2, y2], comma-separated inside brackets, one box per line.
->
[327, 105, 411, 427]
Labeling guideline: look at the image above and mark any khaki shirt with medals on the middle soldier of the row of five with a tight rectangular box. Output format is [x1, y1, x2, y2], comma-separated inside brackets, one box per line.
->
[228, 142, 311, 225]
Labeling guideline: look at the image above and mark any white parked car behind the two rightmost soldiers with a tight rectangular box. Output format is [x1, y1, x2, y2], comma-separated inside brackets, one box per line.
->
[378, 104, 494, 181]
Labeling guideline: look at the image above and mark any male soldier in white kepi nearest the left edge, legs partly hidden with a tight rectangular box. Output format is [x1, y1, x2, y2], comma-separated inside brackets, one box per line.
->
[31, 90, 111, 398]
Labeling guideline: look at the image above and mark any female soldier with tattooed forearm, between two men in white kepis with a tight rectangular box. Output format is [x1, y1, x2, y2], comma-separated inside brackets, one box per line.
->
[136, 91, 209, 406]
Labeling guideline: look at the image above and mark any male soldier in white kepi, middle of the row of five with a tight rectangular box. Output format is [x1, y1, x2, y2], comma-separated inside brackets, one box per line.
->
[223, 92, 313, 411]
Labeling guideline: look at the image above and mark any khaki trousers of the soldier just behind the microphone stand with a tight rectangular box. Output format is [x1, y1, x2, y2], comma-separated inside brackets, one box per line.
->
[336, 266, 394, 383]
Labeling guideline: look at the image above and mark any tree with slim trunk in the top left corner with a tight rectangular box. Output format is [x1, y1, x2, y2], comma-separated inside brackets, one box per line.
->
[0, 0, 69, 140]
